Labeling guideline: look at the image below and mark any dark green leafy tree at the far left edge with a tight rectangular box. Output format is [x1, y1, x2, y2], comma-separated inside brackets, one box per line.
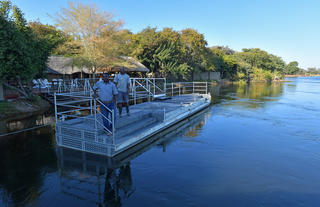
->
[0, 1, 50, 97]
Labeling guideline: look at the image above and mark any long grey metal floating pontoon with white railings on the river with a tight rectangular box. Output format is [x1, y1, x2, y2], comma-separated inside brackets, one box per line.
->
[55, 79, 211, 157]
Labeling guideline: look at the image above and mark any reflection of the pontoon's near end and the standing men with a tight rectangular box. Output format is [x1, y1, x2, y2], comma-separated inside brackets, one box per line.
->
[57, 147, 134, 206]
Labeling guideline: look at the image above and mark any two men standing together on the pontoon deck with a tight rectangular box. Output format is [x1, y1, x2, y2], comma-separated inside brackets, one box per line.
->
[93, 67, 130, 136]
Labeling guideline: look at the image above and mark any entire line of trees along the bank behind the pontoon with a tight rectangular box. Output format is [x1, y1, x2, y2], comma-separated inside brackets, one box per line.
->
[0, 1, 310, 95]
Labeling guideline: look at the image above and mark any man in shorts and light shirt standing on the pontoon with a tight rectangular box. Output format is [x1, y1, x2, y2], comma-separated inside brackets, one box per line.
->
[113, 66, 130, 117]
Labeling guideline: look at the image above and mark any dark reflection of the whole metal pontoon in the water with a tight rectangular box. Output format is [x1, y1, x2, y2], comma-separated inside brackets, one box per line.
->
[56, 110, 208, 207]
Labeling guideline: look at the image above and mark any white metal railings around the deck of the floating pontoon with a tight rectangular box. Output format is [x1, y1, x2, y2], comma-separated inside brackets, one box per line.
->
[54, 78, 208, 146]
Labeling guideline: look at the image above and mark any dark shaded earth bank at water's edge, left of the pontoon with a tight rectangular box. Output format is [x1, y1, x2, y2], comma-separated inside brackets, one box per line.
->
[0, 97, 50, 120]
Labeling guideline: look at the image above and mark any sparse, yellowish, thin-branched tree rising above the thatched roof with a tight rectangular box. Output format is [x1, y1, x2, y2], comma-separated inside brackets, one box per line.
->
[55, 2, 123, 76]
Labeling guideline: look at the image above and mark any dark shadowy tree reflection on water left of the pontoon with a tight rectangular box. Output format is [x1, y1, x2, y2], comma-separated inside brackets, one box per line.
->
[0, 128, 56, 206]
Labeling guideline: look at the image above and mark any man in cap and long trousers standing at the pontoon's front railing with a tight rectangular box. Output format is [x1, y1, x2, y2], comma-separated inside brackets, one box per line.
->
[93, 73, 118, 136]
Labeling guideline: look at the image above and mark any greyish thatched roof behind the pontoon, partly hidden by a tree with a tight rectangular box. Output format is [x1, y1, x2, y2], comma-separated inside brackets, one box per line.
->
[46, 56, 149, 75]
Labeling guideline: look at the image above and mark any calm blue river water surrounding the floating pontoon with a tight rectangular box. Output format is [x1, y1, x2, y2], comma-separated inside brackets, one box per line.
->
[0, 78, 320, 207]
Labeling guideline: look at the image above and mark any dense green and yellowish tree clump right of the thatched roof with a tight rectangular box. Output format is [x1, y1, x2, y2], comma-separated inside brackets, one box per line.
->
[126, 27, 214, 79]
